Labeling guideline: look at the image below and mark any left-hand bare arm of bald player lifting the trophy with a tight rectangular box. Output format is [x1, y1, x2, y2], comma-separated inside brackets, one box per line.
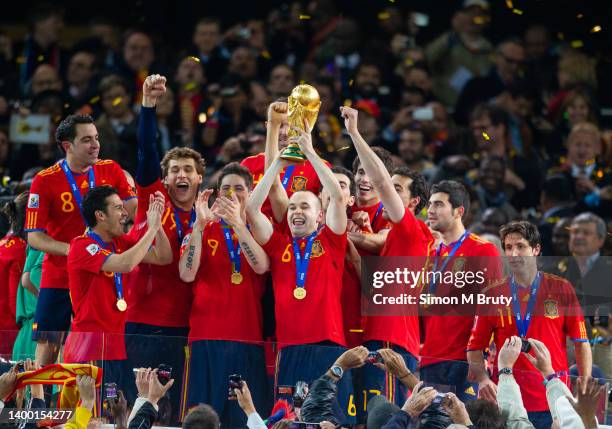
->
[246, 157, 283, 245]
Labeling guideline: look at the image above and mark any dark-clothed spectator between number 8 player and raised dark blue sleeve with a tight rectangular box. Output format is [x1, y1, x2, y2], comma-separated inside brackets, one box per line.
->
[96, 75, 138, 173]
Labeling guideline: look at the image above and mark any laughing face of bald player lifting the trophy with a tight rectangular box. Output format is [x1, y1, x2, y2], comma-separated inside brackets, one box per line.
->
[287, 191, 323, 237]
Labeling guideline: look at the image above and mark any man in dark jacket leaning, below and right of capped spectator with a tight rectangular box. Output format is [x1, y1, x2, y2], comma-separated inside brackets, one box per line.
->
[455, 39, 525, 124]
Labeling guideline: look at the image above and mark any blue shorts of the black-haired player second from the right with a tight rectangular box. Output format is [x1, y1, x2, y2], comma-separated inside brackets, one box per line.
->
[419, 361, 478, 402]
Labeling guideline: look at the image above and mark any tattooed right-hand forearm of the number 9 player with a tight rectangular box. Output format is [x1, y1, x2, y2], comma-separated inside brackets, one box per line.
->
[215, 194, 270, 274]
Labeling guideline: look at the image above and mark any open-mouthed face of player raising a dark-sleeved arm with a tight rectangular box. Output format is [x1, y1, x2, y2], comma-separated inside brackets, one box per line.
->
[164, 158, 202, 205]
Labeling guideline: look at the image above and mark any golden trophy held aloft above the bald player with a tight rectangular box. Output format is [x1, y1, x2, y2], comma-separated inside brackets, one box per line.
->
[281, 85, 321, 162]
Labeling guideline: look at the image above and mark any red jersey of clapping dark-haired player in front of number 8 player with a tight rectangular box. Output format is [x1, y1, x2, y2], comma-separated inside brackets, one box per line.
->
[64, 231, 136, 362]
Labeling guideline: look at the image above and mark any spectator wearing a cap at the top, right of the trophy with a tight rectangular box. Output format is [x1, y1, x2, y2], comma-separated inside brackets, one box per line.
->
[425, 0, 493, 106]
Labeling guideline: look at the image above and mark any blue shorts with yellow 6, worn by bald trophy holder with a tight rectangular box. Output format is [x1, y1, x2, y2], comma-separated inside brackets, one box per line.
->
[274, 343, 357, 424]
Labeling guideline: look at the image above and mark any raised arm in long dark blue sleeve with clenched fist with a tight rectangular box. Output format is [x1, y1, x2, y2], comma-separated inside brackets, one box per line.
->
[136, 75, 166, 186]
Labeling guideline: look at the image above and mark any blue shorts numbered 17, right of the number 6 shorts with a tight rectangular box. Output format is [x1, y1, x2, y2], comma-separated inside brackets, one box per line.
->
[353, 341, 417, 423]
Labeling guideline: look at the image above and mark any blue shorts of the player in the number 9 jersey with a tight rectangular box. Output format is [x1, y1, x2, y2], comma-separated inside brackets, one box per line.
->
[182, 340, 271, 428]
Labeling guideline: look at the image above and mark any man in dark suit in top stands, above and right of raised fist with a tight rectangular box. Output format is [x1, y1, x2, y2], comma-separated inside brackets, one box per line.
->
[192, 18, 230, 82]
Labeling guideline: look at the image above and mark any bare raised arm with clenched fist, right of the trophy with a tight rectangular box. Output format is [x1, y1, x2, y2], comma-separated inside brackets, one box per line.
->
[340, 106, 406, 223]
